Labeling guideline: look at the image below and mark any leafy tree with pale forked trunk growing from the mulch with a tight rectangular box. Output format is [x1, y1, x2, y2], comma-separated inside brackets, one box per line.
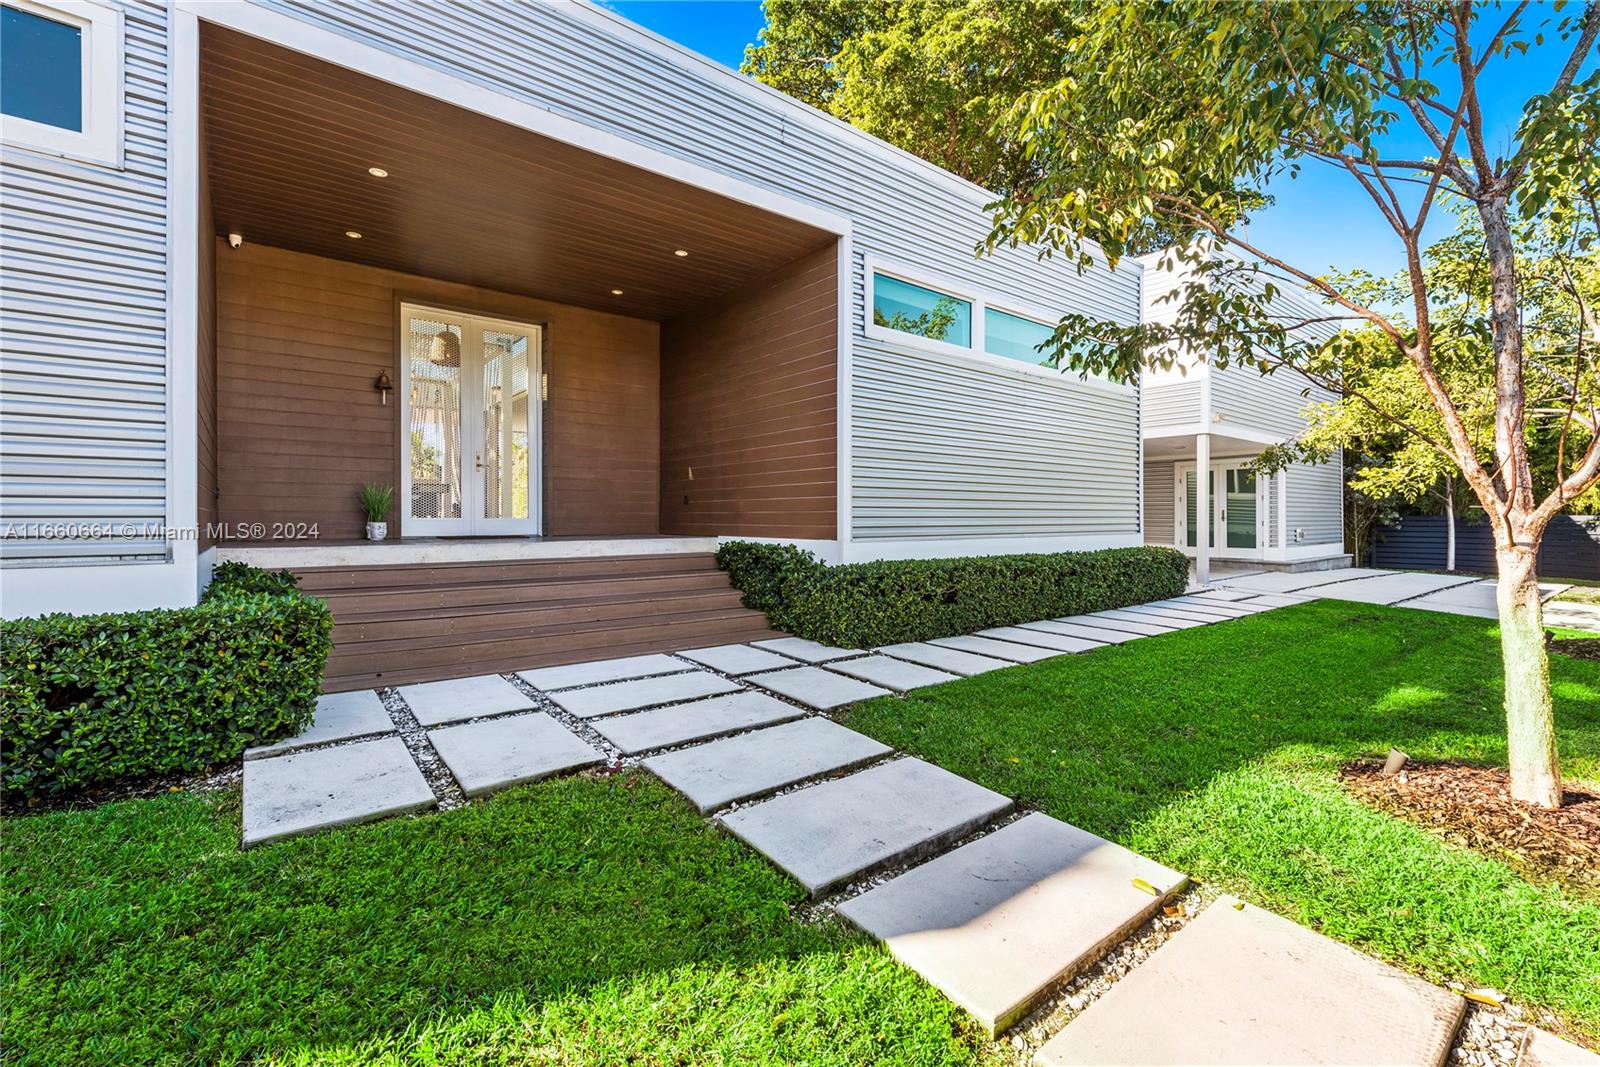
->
[990, 0, 1600, 808]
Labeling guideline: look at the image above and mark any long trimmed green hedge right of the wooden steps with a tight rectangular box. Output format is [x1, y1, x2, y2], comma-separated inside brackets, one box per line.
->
[717, 541, 1189, 648]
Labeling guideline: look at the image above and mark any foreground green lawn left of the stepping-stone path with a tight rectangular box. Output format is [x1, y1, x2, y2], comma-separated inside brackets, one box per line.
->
[0, 776, 992, 1067]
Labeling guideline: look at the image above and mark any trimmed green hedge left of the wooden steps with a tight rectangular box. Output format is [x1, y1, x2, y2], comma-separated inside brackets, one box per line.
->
[0, 563, 333, 800]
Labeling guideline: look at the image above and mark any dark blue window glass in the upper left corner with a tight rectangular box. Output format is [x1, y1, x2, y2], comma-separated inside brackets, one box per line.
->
[0, 6, 83, 133]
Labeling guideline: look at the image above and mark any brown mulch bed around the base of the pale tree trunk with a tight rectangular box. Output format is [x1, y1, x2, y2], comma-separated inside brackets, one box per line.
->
[1341, 764, 1600, 896]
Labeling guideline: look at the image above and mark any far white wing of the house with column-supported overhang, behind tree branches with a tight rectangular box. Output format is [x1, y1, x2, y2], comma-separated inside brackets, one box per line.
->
[1141, 253, 1350, 579]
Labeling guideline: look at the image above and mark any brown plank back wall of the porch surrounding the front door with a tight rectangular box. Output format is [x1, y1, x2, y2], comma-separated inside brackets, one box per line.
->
[214, 238, 661, 537]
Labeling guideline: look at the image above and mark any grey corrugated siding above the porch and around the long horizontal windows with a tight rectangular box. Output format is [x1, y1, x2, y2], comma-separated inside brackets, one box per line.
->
[259, 0, 1141, 539]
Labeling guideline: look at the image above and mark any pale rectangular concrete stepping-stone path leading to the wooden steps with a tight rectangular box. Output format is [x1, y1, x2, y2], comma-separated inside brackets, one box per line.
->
[243, 588, 1484, 1067]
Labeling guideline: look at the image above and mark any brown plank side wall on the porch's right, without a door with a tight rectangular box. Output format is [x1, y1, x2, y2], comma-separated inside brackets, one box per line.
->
[661, 246, 838, 539]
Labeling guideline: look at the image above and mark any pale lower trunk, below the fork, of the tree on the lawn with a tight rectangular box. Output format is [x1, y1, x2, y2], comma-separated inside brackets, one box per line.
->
[1494, 542, 1562, 808]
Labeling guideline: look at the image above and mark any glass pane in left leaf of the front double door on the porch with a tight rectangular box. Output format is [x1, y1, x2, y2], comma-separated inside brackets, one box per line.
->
[405, 314, 466, 522]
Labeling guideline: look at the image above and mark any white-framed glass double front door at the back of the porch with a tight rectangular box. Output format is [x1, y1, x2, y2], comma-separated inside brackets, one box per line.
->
[400, 304, 541, 536]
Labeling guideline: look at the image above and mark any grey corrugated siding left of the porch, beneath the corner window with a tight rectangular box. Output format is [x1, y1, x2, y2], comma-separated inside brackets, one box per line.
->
[0, 0, 168, 563]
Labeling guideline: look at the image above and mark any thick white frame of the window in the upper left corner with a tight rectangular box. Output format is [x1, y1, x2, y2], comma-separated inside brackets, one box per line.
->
[0, 0, 123, 168]
